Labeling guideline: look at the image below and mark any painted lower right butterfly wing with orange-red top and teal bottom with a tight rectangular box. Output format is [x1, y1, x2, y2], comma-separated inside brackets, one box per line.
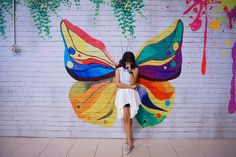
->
[136, 79, 175, 128]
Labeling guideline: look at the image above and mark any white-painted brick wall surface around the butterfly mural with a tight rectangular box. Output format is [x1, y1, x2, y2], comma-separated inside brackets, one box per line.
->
[0, 0, 236, 138]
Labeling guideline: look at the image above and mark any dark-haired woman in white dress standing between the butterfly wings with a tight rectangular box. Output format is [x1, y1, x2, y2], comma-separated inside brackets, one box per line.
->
[115, 52, 141, 153]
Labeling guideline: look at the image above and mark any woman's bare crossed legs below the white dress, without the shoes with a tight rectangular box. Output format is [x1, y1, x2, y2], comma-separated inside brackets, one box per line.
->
[123, 107, 133, 146]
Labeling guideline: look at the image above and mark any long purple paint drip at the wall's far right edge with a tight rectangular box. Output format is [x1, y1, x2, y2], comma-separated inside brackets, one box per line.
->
[228, 42, 236, 113]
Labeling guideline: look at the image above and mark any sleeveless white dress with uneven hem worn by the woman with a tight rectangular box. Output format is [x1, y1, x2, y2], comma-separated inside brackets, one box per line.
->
[115, 67, 141, 119]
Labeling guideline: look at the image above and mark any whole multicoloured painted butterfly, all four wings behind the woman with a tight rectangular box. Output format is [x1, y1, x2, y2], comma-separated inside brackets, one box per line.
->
[60, 19, 183, 128]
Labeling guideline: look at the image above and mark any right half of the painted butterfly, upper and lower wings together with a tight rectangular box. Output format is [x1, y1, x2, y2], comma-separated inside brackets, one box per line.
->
[136, 20, 183, 127]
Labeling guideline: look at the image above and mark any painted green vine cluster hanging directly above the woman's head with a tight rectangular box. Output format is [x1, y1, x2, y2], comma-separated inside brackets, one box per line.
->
[111, 0, 144, 38]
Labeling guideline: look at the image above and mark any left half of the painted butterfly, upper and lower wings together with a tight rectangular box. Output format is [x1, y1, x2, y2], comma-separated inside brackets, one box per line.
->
[61, 20, 117, 127]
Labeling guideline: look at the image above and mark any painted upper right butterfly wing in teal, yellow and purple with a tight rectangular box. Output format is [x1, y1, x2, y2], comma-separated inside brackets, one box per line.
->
[136, 20, 183, 81]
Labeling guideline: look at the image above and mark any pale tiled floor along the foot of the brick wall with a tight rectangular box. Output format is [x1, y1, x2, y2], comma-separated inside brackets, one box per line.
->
[0, 137, 236, 157]
